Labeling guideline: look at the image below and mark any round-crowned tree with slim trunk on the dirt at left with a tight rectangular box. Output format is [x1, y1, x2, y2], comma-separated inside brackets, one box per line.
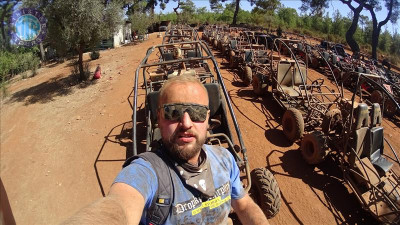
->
[45, 0, 123, 80]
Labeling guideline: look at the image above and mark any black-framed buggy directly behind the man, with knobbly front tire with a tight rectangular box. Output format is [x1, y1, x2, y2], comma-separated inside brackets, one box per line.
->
[132, 38, 281, 218]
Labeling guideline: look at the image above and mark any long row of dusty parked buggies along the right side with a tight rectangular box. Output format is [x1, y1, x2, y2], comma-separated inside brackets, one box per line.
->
[202, 25, 400, 224]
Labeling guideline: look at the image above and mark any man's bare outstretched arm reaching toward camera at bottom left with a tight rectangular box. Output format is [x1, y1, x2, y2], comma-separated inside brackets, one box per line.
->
[62, 183, 144, 225]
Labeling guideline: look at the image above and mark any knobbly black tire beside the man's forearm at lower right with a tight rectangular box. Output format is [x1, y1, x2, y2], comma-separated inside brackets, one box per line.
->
[251, 168, 281, 219]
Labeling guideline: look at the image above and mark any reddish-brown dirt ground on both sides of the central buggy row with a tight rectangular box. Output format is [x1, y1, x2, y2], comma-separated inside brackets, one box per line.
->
[0, 34, 400, 225]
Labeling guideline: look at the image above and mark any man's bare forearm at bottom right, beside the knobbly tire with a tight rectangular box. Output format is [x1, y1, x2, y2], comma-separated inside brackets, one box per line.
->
[232, 194, 269, 225]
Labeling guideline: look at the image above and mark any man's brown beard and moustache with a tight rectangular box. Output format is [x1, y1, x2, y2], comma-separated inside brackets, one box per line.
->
[163, 130, 206, 162]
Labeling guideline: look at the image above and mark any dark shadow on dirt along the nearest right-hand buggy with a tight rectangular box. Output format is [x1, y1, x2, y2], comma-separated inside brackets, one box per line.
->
[266, 149, 379, 225]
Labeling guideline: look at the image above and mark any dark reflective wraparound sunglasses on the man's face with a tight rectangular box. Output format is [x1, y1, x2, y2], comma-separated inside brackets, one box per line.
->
[162, 103, 208, 122]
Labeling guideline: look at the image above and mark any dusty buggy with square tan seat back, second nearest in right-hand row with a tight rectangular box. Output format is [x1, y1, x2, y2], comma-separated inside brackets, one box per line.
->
[252, 38, 343, 142]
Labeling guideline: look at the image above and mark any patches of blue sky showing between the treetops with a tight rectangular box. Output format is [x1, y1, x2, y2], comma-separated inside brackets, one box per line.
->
[152, 0, 400, 33]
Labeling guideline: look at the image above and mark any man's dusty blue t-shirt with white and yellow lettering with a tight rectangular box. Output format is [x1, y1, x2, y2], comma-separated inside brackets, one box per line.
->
[114, 145, 245, 224]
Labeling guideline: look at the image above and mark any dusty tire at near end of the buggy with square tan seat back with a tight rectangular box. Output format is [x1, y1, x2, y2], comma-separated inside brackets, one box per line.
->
[282, 108, 304, 142]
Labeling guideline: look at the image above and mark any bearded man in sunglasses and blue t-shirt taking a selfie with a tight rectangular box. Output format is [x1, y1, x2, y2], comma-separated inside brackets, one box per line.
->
[62, 76, 268, 224]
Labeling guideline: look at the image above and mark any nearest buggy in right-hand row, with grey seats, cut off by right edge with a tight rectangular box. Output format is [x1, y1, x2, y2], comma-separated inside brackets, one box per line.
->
[300, 74, 400, 224]
